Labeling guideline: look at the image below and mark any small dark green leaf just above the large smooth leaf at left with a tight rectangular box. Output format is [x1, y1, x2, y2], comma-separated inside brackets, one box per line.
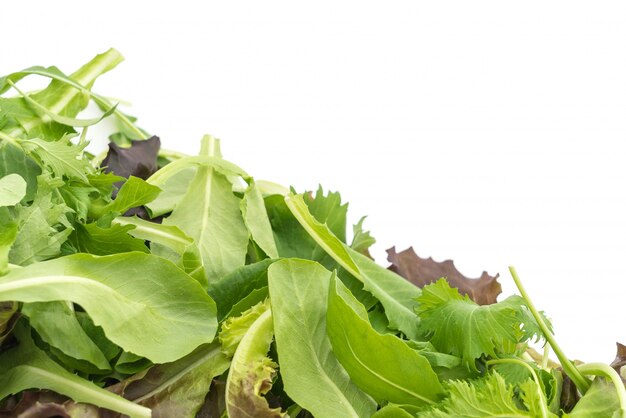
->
[69, 223, 149, 255]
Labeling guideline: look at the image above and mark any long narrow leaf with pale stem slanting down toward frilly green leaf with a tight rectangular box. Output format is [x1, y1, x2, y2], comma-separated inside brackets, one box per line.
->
[285, 195, 421, 339]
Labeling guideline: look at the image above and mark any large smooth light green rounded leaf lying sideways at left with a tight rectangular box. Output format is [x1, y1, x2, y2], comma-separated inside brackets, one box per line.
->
[0, 253, 217, 363]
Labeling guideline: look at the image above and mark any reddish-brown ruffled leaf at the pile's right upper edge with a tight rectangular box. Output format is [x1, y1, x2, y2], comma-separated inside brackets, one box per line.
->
[387, 247, 502, 305]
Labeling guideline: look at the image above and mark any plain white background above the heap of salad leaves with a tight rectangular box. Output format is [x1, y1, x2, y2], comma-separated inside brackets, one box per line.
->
[0, 1, 626, 362]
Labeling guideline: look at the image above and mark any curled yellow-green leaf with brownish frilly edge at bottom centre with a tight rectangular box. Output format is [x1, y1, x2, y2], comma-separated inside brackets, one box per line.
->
[226, 310, 285, 418]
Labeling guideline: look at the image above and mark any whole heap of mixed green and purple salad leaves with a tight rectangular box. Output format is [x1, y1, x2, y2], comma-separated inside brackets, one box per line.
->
[0, 50, 626, 418]
